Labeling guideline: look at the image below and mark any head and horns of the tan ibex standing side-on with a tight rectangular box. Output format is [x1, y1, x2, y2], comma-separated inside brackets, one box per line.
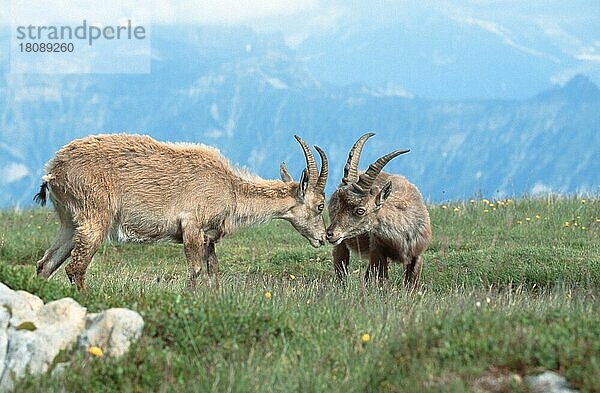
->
[279, 135, 328, 247]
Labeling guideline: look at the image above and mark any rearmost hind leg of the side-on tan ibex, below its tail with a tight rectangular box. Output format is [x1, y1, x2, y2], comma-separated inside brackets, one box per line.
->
[36, 203, 75, 279]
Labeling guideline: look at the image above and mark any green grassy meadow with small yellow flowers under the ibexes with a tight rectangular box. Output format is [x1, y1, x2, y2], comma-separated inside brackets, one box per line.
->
[0, 198, 600, 392]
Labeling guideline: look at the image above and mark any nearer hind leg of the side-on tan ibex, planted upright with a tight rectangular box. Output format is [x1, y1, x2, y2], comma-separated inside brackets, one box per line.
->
[65, 221, 110, 292]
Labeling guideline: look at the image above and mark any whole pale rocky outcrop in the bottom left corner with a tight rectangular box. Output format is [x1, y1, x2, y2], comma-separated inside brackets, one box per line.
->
[0, 283, 144, 391]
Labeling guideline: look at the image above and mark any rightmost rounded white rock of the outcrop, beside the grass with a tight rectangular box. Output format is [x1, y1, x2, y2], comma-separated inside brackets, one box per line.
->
[79, 308, 144, 357]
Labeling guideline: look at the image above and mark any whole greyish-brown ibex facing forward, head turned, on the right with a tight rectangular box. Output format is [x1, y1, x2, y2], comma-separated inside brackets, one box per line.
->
[327, 133, 431, 289]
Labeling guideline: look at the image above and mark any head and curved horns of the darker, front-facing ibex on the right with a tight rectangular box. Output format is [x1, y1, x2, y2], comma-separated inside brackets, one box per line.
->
[326, 133, 409, 244]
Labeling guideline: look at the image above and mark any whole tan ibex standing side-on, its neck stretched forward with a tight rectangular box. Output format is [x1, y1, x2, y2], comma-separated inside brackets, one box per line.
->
[36, 134, 327, 291]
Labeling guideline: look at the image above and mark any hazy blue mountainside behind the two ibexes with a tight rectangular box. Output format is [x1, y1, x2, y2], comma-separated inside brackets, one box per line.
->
[0, 27, 600, 207]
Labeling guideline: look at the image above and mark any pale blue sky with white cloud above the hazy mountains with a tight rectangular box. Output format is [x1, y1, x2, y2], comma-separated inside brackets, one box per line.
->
[0, 0, 600, 99]
